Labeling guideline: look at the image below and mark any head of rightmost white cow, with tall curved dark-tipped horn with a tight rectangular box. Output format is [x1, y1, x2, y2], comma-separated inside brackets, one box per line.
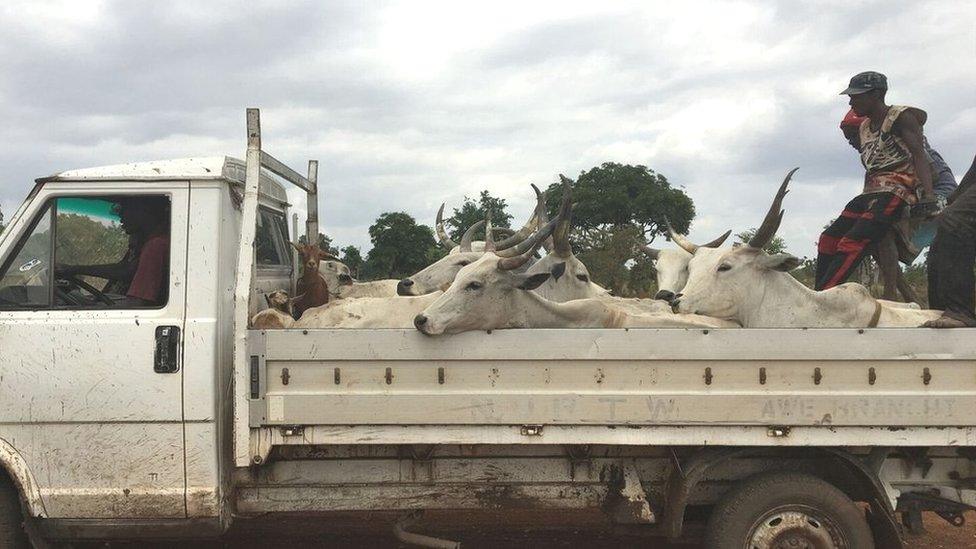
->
[672, 168, 800, 321]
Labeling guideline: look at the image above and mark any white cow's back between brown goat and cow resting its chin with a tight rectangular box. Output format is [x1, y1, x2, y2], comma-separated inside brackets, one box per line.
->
[292, 292, 441, 329]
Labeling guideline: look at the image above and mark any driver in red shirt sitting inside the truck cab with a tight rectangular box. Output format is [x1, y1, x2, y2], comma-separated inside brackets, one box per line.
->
[55, 196, 169, 307]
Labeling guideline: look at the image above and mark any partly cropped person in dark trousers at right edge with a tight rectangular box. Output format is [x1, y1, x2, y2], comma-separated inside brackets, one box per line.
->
[924, 152, 976, 328]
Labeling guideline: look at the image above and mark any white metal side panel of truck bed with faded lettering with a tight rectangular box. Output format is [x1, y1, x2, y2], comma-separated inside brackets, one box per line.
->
[238, 328, 976, 456]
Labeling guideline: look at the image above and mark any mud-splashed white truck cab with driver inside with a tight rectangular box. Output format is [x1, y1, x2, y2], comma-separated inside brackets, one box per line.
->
[0, 153, 294, 536]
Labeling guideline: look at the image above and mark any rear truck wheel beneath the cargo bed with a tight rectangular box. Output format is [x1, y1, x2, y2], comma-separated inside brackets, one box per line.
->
[705, 472, 874, 549]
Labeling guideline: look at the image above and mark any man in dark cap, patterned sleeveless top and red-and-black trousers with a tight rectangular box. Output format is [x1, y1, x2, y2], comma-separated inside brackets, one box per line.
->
[815, 71, 938, 290]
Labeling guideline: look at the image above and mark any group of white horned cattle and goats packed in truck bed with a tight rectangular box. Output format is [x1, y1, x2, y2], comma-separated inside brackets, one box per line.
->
[252, 169, 941, 335]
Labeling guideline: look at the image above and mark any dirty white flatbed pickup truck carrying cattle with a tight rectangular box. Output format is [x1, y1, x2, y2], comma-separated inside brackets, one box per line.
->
[0, 109, 976, 548]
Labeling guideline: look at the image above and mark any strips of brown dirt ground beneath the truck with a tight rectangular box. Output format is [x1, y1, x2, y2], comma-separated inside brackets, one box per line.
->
[82, 513, 976, 549]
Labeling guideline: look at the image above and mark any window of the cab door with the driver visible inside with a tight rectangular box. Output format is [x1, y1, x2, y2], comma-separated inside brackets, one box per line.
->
[0, 195, 170, 310]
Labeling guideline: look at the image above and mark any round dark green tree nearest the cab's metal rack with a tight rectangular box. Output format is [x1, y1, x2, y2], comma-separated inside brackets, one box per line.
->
[362, 212, 442, 280]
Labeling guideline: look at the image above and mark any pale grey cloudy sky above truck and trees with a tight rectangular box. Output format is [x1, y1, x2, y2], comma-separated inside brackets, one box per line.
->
[0, 0, 976, 255]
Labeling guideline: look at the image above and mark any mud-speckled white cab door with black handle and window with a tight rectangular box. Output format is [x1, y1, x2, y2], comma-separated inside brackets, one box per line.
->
[0, 182, 189, 518]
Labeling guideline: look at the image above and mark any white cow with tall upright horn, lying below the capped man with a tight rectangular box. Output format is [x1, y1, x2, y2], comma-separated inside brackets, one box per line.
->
[674, 169, 941, 328]
